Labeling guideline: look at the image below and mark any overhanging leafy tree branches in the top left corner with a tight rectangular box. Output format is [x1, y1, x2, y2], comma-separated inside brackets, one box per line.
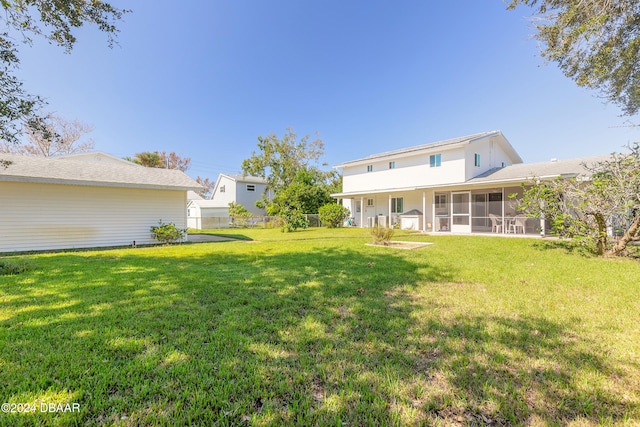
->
[0, 0, 129, 144]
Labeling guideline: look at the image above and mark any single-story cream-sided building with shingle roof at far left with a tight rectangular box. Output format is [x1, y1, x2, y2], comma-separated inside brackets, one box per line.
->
[0, 153, 200, 252]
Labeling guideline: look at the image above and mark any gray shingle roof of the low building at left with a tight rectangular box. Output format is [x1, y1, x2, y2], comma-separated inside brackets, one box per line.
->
[0, 153, 202, 190]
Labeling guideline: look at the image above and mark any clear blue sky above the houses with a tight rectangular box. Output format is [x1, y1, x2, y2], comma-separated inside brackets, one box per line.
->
[12, 0, 640, 179]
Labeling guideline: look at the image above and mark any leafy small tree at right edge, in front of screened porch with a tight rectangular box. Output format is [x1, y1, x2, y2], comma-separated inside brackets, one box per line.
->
[519, 143, 640, 256]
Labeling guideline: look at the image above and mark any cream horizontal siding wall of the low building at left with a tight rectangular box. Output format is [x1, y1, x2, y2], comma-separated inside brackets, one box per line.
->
[0, 182, 187, 252]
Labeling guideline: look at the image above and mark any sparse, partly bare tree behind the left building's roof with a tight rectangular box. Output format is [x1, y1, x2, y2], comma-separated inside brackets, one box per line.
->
[0, 114, 95, 157]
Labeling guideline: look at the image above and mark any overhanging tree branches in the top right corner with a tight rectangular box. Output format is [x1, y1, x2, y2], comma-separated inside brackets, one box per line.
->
[508, 0, 640, 115]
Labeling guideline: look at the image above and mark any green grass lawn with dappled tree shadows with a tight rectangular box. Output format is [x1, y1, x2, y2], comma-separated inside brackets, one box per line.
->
[0, 229, 640, 426]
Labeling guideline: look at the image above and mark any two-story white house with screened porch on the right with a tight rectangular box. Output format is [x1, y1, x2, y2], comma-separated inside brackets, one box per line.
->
[332, 131, 607, 234]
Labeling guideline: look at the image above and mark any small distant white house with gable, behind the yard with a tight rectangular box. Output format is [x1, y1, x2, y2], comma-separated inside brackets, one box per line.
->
[211, 174, 267, 216]
